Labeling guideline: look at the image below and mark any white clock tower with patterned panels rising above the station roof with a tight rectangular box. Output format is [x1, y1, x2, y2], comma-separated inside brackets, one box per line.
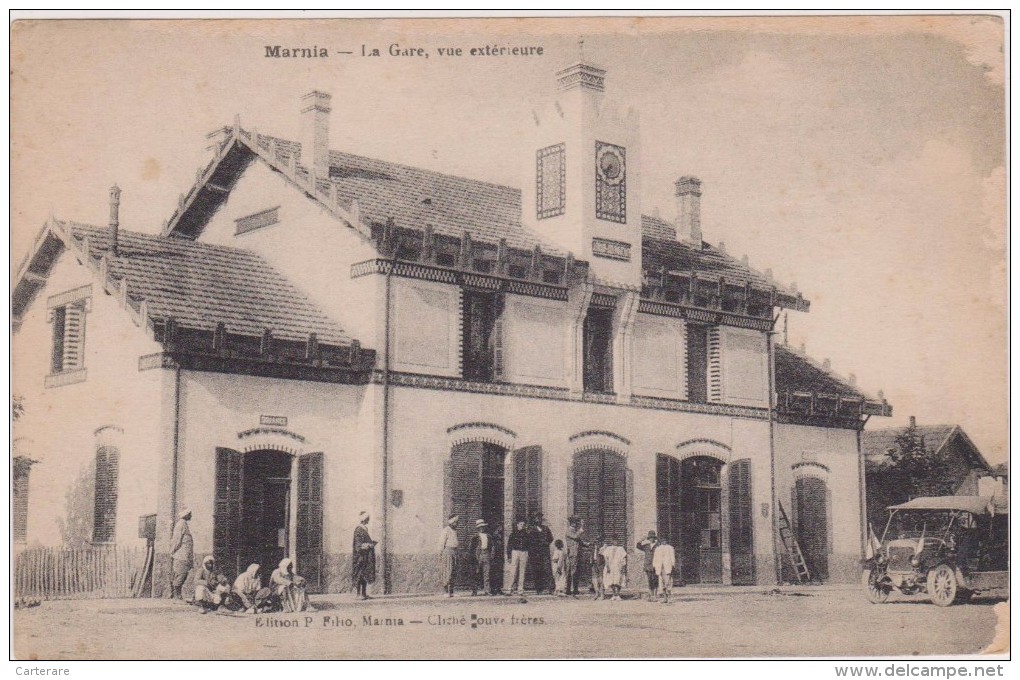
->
[521, 49, 642, 289]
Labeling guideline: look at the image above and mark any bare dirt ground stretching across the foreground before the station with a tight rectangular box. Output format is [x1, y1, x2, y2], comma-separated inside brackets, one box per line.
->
[14, 586, 1007, 660]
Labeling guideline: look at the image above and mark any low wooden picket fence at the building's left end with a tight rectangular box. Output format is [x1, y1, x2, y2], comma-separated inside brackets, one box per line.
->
[14, 546, 148, 599]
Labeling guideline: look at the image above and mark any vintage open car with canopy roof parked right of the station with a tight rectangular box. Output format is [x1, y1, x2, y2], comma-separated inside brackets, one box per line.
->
[861, 495, 1009, 607]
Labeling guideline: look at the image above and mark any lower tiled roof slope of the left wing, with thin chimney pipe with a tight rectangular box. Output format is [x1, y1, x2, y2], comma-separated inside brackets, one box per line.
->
[67, 223, 351, 345]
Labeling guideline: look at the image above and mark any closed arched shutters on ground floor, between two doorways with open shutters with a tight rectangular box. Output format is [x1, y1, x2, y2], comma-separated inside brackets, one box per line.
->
[573, 450, 627, 545]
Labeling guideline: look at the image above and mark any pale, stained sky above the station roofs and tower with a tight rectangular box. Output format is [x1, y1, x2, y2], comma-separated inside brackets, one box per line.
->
[11, 16, 1008, 463]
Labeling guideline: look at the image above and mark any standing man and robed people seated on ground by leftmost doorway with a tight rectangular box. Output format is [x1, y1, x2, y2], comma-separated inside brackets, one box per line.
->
[170, 510, 315, 614]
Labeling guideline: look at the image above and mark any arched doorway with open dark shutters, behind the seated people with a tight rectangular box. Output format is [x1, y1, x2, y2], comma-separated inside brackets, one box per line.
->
[213, 449, 322, 589]
